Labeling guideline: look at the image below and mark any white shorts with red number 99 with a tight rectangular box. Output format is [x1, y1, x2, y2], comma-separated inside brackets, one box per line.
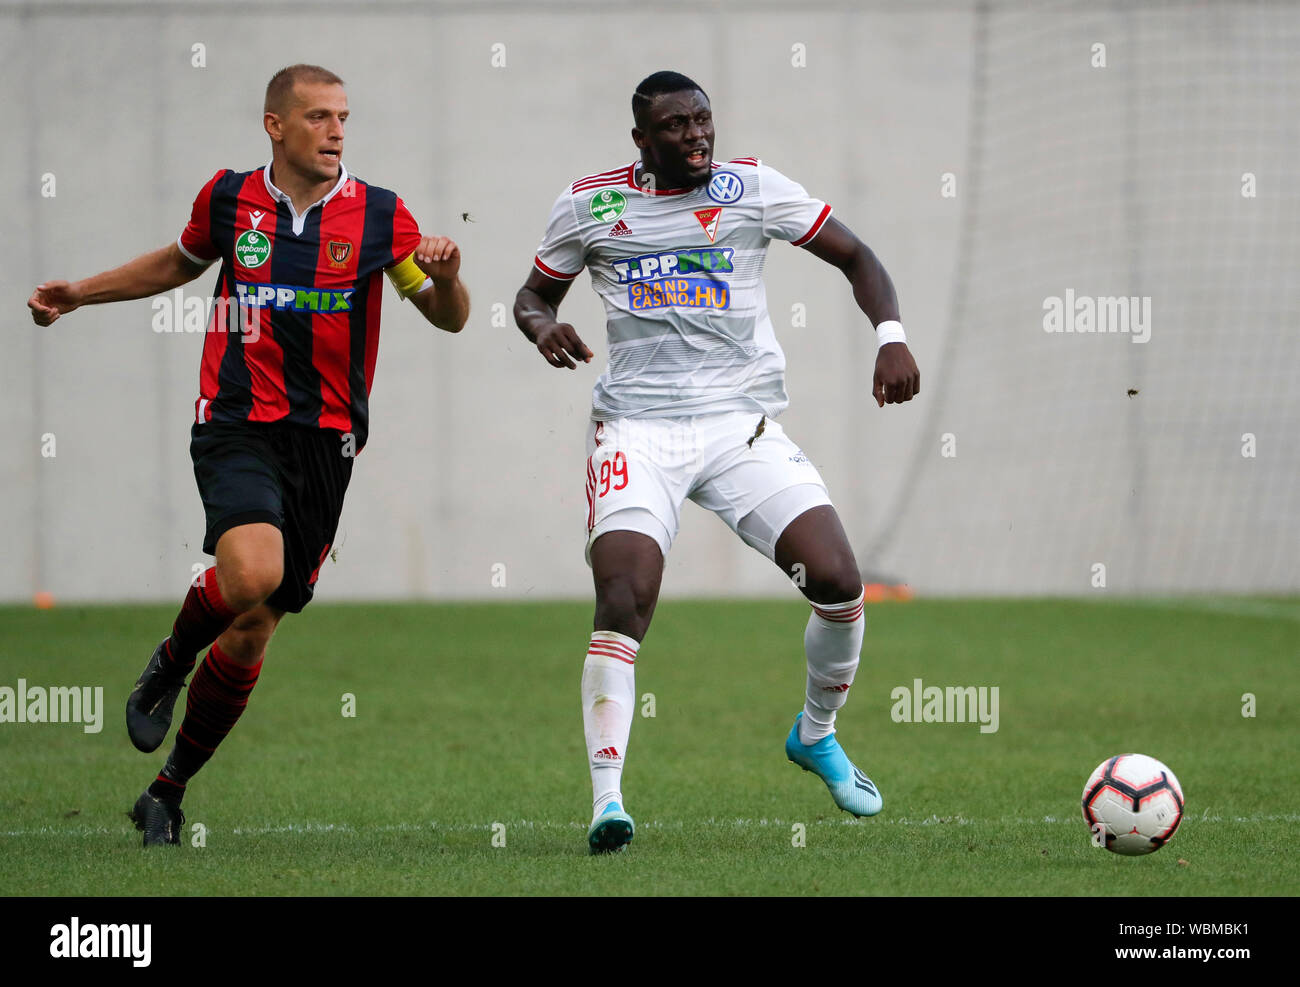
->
[586, 411, 831, 564]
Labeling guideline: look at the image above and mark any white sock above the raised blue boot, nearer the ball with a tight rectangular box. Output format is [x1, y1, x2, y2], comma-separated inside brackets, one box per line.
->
[800, 596, 867, 744]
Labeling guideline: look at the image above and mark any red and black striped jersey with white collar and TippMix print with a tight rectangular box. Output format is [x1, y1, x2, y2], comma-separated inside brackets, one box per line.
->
[178, 164, 425, 450]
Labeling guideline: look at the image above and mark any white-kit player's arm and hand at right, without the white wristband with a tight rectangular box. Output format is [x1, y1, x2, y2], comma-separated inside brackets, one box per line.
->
[803, 217, 920, 407]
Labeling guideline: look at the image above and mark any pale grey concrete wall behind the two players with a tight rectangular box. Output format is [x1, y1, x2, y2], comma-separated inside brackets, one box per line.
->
[0, 1, 1300, 599]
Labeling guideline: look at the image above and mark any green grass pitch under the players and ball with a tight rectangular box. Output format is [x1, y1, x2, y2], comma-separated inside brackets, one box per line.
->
[0, 597, 1300, 896]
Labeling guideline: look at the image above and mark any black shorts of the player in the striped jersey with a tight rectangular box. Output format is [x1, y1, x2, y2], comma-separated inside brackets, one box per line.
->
[190, 421, 352, 614]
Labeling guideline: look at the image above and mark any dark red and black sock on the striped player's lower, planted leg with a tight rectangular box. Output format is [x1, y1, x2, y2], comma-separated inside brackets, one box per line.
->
[150, 645, 261, 801]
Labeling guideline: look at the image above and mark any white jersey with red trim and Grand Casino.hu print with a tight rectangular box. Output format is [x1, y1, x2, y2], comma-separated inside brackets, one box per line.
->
[534, 157, 831, 421]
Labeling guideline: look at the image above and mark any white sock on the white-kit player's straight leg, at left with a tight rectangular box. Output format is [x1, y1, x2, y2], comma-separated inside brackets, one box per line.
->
[582, 631, 641, 818]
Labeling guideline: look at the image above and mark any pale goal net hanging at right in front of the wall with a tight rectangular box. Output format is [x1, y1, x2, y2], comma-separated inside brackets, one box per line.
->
[863, 3, 1300, 593]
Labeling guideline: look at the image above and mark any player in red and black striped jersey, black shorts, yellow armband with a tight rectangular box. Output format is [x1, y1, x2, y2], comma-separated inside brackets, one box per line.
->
[27, 65, 469, 847]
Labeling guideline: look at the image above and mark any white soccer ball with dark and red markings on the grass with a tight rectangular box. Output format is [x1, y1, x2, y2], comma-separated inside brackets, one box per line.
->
[1083, 754, 1183, 857]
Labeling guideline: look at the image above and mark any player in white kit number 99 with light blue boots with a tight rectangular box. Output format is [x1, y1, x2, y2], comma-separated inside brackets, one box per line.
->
[515, 72, 920, 853]
